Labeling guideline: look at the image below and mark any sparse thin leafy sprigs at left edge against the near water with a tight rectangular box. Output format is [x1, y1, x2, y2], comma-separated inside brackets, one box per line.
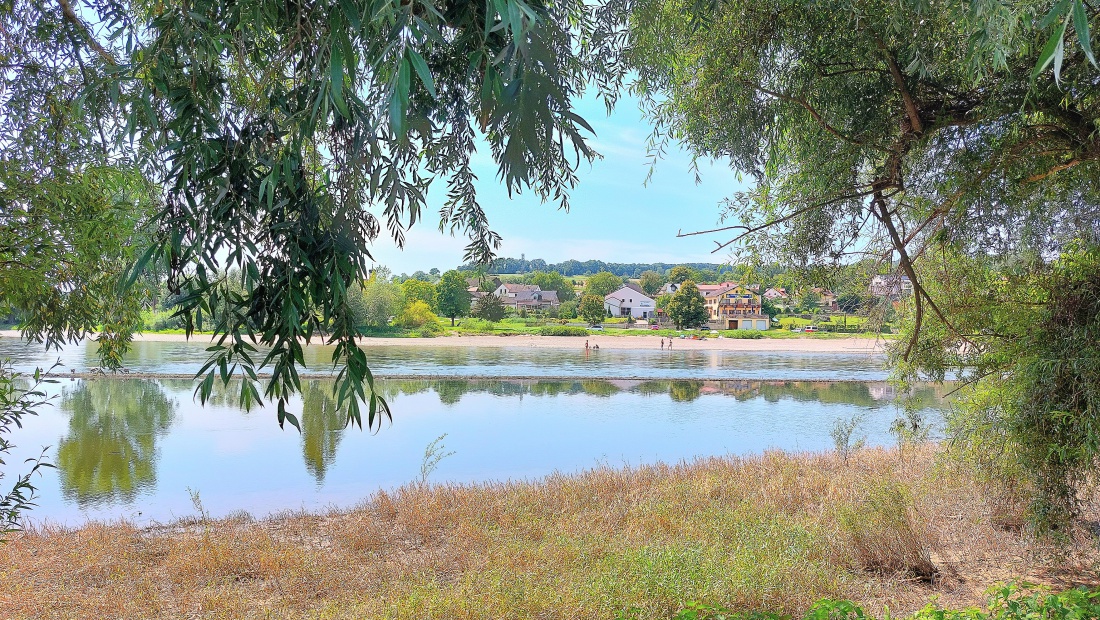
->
[0, 359, 52, 536]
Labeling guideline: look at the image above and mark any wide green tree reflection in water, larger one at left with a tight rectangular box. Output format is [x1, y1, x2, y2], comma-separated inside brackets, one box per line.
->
[56, 379, 177, 507]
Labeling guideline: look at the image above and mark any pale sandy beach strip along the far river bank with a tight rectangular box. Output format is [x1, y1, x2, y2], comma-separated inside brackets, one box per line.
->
[0, 330, 886, 354]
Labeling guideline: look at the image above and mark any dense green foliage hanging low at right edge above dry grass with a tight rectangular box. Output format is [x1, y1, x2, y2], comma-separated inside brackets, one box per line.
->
[895, 243, 1100, 529]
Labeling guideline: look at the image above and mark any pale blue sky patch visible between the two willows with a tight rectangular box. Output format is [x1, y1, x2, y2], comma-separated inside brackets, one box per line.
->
[372, 97, 745, 274]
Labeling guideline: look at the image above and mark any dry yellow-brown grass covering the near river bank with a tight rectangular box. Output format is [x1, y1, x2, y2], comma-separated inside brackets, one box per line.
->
[0, 447, 1098, 619]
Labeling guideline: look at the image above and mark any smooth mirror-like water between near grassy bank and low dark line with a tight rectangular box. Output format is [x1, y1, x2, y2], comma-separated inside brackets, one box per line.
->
[9, 375, 942, 524]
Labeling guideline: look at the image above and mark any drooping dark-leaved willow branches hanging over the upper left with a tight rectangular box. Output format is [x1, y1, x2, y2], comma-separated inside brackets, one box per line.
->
[0, 0, 613, 425]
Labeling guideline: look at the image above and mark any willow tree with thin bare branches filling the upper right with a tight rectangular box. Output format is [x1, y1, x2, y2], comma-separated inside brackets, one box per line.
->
[620, 0, 1100, 523]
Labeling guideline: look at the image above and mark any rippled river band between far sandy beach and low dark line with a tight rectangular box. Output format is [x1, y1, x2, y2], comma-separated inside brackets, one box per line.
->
[0, 339, 887, 381]
